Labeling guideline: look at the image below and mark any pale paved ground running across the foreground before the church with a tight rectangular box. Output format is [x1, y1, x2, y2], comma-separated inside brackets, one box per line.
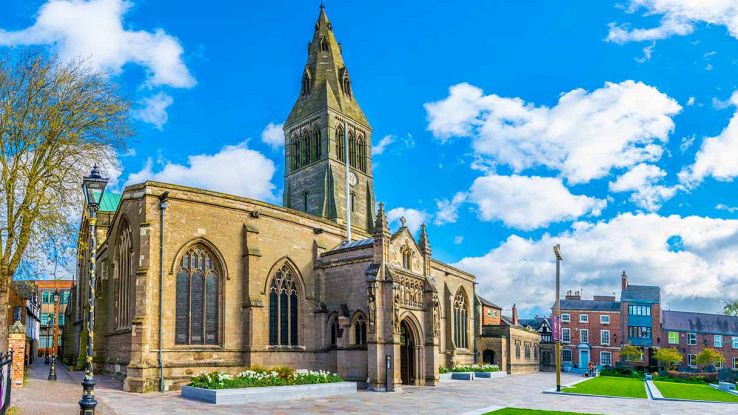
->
[16, 368, 738, 415]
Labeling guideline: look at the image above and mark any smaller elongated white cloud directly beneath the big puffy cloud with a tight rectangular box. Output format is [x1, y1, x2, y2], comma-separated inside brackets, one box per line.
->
[469, 174, 607, 230]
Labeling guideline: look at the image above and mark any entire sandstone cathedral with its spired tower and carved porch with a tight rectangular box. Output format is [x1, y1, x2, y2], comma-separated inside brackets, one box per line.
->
[64, 6, 476, 392]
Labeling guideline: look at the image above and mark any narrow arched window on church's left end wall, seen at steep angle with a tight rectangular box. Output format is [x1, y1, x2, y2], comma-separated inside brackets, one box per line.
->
[115, 220, 135, 329]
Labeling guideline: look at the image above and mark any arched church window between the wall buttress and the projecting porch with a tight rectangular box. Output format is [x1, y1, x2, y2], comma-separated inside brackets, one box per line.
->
[269, 264, 298, 346]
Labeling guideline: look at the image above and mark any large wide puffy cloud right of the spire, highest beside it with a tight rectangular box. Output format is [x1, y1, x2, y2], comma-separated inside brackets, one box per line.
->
[425, 81, 681, 183]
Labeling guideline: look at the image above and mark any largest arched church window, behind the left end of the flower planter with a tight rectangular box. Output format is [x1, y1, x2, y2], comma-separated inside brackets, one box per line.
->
[175, 244, 220, 344]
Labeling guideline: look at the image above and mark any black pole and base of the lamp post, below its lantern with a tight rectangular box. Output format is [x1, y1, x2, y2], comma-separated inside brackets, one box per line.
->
[79, 206, 97, 415]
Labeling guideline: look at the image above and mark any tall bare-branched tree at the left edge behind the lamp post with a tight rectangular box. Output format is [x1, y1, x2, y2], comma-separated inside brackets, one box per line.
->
[0, 49, 132, 350]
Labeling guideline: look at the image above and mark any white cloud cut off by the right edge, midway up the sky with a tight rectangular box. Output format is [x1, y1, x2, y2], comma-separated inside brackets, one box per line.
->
[679, 92, 738, 186]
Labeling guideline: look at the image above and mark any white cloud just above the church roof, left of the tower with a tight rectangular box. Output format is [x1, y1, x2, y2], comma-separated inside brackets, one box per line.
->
[126, 142, 275, 201]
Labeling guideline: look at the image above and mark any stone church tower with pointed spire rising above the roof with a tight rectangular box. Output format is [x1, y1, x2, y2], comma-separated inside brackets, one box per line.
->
[283, 5, 374, 231]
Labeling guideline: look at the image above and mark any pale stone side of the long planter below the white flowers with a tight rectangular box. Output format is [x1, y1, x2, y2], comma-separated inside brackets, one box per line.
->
[181, 382, 356, 405]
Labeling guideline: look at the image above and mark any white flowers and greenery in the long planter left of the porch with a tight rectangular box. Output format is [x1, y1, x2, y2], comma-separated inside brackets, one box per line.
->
[191, 367, 343, 389]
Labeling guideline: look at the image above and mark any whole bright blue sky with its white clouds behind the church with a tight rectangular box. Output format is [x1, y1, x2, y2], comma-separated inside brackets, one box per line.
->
[0, 0, 738, 315]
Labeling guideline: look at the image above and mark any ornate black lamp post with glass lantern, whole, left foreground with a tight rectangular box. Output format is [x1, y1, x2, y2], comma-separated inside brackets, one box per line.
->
[79, 165, 108, 415]
